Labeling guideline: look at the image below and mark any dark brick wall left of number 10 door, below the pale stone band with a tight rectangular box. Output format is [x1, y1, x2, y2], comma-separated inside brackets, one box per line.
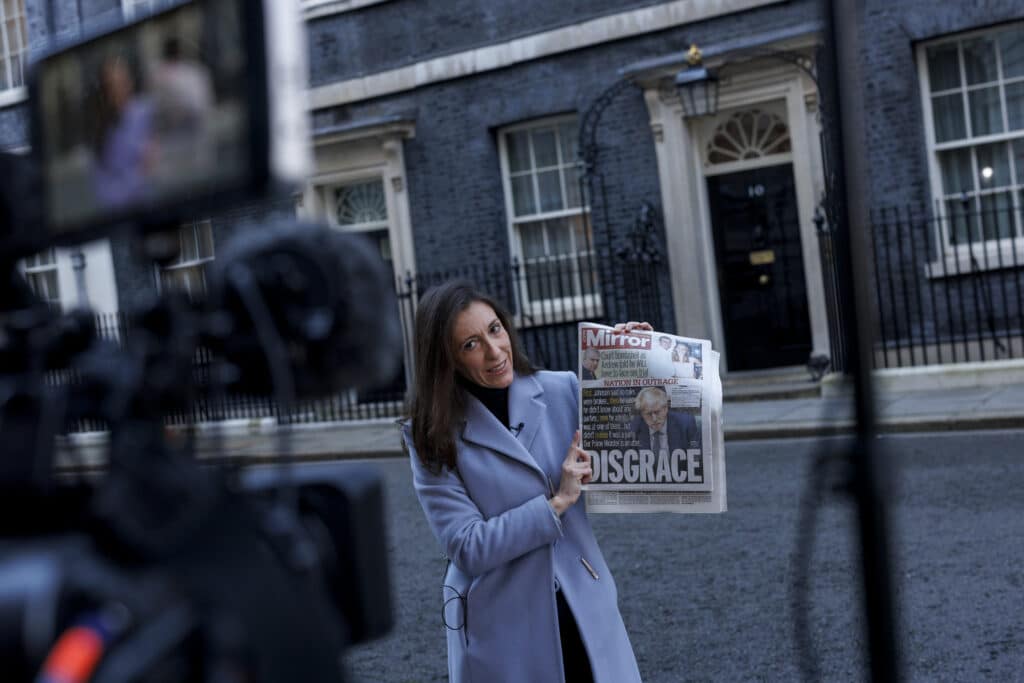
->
[313, 2, 812, 326]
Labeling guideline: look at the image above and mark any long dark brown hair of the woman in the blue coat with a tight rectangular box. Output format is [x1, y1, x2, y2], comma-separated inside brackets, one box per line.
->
[407, 280, 536, 472]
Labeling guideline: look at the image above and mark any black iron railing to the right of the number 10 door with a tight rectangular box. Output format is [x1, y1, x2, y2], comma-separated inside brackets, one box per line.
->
[818, 202, 1024, 368]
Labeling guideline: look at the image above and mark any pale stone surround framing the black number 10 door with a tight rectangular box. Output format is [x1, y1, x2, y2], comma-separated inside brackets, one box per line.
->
[625, 34, 829, 370]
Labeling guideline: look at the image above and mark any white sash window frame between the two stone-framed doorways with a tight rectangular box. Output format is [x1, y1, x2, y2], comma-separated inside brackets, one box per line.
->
[498, 114, 602, 327]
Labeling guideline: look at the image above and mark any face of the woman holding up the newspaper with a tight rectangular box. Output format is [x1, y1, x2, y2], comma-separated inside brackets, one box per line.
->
[452, 301, 514, 389]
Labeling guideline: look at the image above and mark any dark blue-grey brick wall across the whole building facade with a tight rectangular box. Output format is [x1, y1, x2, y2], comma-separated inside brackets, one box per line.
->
[9, 0, 1024, 362]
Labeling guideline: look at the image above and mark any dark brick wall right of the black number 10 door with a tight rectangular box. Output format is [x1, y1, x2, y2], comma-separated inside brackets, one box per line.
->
[861, 0, 1024, 352]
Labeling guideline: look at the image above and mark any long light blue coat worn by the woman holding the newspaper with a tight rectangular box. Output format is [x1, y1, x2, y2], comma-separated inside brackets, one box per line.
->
[406, 372, 640, 683]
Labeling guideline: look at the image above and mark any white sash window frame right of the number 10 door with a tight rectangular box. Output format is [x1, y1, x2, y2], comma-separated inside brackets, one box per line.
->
[916, 22, 1024, 278]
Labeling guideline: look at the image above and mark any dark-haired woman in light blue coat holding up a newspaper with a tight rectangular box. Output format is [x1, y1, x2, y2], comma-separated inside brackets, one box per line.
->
[404, 282, 638, 683]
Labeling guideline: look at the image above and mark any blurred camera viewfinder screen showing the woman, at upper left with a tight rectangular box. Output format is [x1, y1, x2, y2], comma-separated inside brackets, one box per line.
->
[38, 1, 251, 232]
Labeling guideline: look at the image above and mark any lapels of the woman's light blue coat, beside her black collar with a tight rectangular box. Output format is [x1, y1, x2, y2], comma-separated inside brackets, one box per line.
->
[462, 375, 547, 480]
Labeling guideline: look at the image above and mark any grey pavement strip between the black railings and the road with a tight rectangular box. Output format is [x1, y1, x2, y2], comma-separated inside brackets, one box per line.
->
[58, 361, 1024, 468]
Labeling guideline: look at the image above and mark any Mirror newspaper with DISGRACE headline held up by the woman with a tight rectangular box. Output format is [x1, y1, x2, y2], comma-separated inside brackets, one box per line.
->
[579, 323, 726, 512]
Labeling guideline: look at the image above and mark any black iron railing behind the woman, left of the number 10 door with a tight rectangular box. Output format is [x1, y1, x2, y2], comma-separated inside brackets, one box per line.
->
[59, 248, 660, 431]
